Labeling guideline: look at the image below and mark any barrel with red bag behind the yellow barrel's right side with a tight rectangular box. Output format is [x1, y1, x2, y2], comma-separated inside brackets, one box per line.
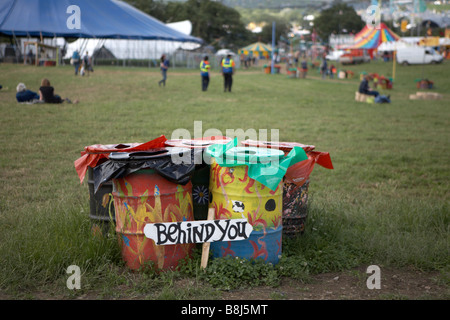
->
[242, 140, 333, 237]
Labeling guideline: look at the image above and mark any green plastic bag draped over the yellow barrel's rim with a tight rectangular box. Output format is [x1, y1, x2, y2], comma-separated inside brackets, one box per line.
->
[206, 138, 308, 190]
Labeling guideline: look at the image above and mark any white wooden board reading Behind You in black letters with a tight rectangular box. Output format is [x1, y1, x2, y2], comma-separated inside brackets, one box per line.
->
[144, 219, 253, 245]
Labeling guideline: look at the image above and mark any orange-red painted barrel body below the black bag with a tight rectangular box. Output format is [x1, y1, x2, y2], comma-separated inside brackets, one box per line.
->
[113, 170, 194, 269]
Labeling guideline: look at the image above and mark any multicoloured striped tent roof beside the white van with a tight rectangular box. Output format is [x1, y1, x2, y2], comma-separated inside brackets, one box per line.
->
[351, 23, 400, 49]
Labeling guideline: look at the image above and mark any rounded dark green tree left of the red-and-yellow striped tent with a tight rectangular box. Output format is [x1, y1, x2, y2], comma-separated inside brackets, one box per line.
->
[314, 1, 364, 41]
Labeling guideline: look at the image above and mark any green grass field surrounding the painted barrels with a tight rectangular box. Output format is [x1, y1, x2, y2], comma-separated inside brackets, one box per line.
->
[0, 61, 450, 299]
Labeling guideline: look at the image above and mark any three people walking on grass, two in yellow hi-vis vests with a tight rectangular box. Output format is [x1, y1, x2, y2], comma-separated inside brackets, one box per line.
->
[158, 55, 236, 92]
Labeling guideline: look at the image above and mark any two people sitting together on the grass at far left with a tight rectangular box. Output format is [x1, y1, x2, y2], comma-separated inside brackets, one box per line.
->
[16, 78, 78, 103]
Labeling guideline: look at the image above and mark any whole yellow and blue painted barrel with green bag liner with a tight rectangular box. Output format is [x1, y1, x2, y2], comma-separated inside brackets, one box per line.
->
[207, 141, 306, 264]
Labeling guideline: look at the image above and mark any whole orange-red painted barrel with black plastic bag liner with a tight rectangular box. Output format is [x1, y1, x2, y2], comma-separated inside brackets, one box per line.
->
[96, 148, 194, 270]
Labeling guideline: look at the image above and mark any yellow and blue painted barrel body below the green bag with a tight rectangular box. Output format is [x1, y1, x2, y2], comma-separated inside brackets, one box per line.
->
[209, 159, 283, 264]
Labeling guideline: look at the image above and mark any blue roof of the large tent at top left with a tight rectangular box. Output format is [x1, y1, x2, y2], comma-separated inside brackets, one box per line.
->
[0, 0, 203, 43]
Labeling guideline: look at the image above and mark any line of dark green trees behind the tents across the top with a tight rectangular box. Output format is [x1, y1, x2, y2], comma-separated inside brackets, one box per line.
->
[125, 0, 364, 50]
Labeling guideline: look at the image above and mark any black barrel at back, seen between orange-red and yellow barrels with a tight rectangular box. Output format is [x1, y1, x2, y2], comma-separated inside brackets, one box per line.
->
[166, 136, 231, 220]
